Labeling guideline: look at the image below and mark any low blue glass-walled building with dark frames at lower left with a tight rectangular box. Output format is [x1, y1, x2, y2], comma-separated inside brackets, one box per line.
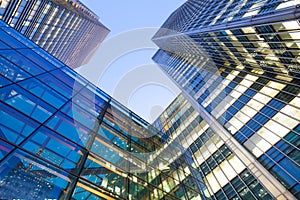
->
[0, 21, 204, 200]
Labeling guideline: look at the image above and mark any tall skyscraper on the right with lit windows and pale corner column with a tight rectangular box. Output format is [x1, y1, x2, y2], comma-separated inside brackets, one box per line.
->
[153, 0, 300, 199]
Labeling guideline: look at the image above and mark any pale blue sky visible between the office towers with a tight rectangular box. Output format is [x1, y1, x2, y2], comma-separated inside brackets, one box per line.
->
[77, 0, 185, 122]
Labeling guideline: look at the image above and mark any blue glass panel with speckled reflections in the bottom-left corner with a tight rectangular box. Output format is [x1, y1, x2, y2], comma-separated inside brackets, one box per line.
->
[0, 150, 75, 199]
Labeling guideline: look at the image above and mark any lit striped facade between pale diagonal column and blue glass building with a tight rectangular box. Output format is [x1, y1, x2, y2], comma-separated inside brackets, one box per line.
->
[154, 95, 274, 199]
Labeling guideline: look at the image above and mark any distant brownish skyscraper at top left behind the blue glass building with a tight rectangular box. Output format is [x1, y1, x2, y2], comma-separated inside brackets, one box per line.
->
[0, 0, 109, 68]
